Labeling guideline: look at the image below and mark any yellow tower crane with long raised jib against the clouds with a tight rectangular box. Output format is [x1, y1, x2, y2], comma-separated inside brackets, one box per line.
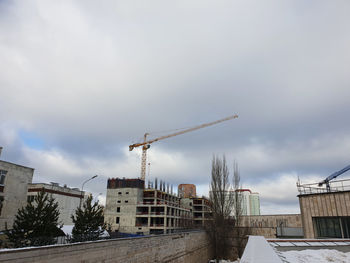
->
[129, 115, 238, 183]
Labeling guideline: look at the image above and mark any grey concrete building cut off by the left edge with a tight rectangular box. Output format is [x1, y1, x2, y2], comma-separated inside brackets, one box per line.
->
[0, 160, 34, 230]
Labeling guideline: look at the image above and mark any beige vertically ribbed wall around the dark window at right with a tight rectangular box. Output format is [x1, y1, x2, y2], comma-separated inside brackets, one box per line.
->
[299, 191, 350, 238]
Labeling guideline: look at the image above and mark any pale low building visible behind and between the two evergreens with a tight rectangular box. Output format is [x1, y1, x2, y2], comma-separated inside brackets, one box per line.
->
[27, 183, 84, 225]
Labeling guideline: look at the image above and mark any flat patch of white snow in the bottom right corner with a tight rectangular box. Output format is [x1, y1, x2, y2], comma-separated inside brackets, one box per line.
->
[278, 249, 350, 263]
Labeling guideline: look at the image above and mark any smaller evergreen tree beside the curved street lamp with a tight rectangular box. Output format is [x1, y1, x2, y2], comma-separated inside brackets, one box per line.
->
[72, 195, 106, 242]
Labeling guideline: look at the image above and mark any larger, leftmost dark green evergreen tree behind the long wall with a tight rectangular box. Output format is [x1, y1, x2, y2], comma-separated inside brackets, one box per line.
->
[6, 191, 64, 247]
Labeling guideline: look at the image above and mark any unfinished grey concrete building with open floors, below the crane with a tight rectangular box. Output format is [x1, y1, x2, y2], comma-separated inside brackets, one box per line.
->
[105, 178, 192, 234]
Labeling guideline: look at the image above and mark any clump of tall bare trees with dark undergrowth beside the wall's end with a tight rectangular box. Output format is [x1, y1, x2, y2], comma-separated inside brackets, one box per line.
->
[207, 156, 246, 259]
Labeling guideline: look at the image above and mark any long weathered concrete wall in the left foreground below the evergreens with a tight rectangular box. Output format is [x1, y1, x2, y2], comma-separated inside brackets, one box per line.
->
[0, 232, 212, 263]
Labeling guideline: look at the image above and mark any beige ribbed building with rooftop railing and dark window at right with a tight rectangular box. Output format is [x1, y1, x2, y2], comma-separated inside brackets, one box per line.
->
[297, 179, 350, 238]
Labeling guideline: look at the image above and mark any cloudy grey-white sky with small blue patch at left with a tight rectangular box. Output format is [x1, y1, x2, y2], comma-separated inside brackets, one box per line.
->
[0, 0, 350, 214]
